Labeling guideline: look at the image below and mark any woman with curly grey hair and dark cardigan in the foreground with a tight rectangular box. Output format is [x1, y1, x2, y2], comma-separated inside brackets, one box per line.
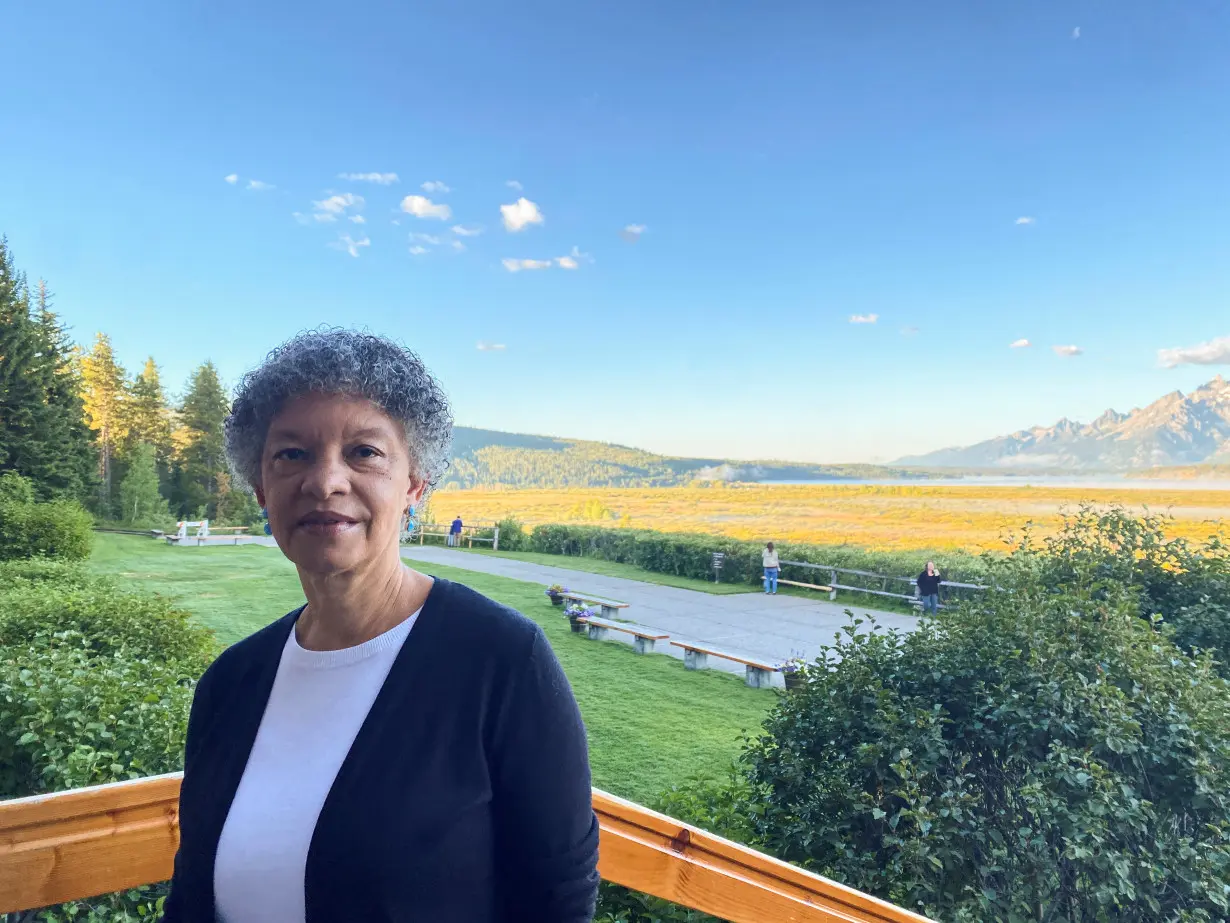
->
[165, 331, 598, 923]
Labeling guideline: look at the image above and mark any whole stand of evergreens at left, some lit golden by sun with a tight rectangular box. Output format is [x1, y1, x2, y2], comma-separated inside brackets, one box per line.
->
[0, 239, 260, 525]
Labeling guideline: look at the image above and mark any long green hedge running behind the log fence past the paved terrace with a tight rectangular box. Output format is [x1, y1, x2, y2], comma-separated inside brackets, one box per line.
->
[523, 525, 988, 603]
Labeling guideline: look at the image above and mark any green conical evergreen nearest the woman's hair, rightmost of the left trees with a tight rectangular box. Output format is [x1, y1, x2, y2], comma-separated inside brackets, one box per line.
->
[173, 362, 230, 518]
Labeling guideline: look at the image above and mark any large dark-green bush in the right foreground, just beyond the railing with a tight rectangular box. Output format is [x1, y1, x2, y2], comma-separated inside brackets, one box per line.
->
[743, 537, 1230, 923]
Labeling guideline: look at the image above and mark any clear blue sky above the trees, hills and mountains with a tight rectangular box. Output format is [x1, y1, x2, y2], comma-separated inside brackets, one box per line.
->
[0, 0, 1230, 462]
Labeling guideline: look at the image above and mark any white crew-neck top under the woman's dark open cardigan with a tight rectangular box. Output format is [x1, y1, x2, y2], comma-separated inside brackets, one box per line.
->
[214, 612, 418, 923]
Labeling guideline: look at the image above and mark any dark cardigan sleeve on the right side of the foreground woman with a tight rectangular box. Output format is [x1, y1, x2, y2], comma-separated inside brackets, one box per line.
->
[490, 626, 599, 923]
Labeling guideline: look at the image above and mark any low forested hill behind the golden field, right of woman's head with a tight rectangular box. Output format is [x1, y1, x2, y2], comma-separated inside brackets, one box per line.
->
[440, 426, 930, 487]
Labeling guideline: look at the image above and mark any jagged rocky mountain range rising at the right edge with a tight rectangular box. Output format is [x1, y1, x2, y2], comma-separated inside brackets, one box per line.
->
[895, 375, 1230, 473]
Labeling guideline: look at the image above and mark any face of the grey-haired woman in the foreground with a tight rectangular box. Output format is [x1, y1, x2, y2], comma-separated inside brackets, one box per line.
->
[256, 394, 423, 573]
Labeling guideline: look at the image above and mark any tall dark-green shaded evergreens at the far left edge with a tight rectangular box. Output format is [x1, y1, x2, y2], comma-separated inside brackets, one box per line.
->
[0, 238, 93, 498]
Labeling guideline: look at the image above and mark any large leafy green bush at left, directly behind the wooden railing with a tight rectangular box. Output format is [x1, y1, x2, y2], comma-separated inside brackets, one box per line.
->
[0, 559, 216, 923]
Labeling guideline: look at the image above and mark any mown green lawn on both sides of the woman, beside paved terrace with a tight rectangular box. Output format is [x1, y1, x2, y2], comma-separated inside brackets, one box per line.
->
[91, 534, 776, 801]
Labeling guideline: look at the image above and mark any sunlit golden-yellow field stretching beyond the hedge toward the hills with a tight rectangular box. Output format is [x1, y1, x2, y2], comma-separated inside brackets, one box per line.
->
[432, 484, 1230, 551]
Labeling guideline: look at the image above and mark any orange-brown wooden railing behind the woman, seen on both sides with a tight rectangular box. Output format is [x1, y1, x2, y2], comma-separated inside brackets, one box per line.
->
[0, 773, 929, 923]
